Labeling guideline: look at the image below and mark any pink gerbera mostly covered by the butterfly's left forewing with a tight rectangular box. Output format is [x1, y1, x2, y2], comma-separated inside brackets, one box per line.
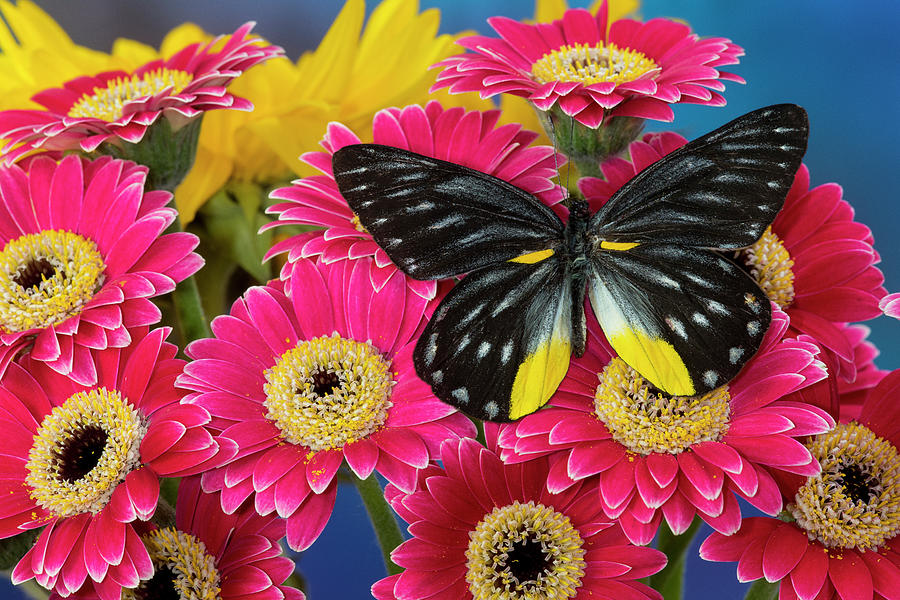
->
[264, 102, 565, 298]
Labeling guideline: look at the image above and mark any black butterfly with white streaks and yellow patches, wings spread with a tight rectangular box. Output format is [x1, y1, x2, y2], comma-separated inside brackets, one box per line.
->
[332, 104, 809, 421]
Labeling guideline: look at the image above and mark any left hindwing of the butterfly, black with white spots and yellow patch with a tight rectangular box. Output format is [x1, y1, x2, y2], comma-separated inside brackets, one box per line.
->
[413, 256, 581, 421]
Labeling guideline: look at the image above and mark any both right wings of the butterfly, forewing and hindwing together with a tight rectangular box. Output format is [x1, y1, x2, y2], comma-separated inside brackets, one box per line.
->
[588, 104, 809, 396]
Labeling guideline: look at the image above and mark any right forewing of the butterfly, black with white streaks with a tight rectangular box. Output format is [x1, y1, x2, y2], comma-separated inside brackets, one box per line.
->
[590, 104, 809, 249]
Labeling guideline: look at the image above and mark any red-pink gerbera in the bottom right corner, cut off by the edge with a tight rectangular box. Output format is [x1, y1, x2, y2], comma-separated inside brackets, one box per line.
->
[700, 371, 900, 600]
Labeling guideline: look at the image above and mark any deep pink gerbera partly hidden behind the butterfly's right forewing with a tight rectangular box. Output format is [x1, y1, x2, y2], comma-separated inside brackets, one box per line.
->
[578, 133, 886, 380]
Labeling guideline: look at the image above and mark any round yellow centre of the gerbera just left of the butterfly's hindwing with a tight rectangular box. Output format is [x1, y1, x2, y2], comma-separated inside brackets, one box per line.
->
[264, 333, 394, 452]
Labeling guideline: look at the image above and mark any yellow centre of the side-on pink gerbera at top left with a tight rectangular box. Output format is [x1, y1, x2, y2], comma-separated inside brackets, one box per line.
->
[69, 68, 194, 121]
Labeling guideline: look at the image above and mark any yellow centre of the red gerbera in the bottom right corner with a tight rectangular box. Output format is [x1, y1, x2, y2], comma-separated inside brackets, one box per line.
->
[787, 423, 900, 550]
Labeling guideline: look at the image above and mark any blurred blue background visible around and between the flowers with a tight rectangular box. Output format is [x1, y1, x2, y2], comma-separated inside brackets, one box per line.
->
[0, 0, 900, 600]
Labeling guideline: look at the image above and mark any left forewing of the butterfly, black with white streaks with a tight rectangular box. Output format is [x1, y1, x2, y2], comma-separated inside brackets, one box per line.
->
[332, 144, 563, 279]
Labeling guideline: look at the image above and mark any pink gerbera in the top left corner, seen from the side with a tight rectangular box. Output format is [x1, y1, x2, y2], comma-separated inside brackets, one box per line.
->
[0, 23, 282, 161]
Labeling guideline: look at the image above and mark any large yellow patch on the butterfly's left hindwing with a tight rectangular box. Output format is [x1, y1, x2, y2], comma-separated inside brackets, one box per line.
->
[509, 330, 572, 419]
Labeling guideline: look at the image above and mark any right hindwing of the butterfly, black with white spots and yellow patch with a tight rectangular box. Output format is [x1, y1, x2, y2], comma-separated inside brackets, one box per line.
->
[588, 244, 771, 396]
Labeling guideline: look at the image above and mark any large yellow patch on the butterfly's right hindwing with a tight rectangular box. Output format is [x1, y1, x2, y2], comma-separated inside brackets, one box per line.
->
[607, 329, 696, 396]
